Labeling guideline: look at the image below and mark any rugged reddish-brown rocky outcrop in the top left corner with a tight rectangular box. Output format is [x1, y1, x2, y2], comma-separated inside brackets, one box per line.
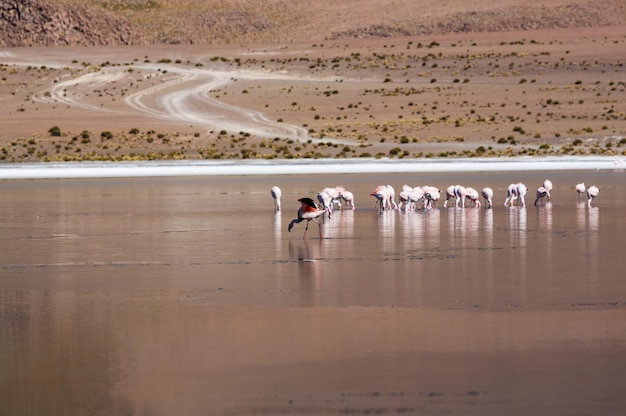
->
[0, 0, 147, 47]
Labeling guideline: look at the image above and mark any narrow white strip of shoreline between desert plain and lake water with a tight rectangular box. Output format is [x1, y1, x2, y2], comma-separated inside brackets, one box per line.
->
[0, 156, 626, 180]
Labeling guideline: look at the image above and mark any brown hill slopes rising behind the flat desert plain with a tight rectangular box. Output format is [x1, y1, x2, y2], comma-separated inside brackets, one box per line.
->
[0, 0, 626, 47]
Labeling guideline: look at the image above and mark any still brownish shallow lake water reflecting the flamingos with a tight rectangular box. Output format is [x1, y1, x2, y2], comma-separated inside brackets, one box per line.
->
[0, 171, 626, 415]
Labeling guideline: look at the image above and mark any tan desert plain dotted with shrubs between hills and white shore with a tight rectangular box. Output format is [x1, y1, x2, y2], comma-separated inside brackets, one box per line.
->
[0, 26, 626, 163]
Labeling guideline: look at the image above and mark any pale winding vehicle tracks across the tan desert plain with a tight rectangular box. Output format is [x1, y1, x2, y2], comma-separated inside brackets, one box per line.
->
[11, 47, 336, 142]
